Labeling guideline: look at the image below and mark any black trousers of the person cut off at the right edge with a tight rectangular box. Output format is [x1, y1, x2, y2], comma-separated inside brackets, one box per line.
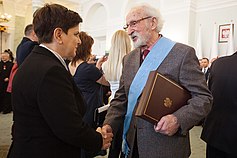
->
[206, 145, 237, 158]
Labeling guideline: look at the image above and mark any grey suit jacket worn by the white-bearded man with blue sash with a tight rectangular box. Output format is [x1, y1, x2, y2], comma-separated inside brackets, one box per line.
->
[104, 43, 212, 158]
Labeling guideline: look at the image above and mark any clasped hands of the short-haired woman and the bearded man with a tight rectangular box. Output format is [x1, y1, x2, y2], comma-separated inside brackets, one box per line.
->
[96, 125, 114, 150]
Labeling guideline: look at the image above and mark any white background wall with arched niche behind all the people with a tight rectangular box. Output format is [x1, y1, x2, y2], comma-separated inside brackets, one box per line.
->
[1, 0, 237, 57]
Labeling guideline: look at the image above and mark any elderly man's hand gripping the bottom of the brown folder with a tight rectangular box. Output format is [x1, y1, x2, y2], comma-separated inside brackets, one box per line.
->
[154, 114, 180, 136]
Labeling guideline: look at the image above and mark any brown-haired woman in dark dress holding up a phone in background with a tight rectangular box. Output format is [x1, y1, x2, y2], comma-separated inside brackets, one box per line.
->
[69, 32, 109, 158]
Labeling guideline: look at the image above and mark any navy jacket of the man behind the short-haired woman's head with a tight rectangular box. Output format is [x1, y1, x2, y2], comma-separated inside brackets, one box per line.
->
[16, 37, 39, 67]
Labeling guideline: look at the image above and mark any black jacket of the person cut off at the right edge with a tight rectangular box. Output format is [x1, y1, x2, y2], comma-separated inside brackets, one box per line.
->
[201, 52, 237, 156]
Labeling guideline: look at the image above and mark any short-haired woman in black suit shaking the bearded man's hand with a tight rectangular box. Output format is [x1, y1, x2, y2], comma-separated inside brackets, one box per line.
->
[9, 4, 113, 158]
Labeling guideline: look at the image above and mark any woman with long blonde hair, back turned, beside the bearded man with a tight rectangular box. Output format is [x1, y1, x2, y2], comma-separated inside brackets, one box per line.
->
[102, 30, 132, 158]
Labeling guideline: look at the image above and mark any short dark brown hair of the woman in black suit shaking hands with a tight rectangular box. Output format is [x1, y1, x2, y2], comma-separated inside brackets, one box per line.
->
[33, 4, 82, 43]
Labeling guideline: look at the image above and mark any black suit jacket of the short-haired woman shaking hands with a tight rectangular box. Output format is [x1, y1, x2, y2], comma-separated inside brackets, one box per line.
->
[10, 46, 102, 158]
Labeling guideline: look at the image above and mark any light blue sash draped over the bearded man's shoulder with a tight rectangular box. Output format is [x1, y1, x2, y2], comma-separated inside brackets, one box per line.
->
[122, 37, 175, 157]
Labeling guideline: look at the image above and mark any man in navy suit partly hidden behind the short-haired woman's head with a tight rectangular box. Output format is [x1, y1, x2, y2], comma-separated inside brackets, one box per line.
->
[16, 24, 38, 67]
